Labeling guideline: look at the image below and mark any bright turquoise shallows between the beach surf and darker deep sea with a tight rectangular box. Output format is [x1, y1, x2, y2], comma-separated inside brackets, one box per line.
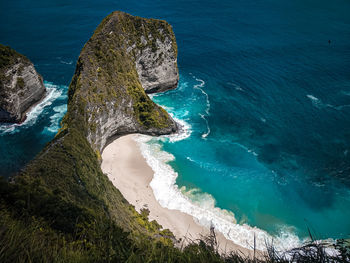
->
[146, 74, 350, 250]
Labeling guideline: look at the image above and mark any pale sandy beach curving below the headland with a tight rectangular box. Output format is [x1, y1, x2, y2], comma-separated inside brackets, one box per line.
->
[101, 135, 260, 257]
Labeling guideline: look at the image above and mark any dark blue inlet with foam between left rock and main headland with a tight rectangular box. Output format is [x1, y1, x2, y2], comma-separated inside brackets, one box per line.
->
[0, 81, 68, 177]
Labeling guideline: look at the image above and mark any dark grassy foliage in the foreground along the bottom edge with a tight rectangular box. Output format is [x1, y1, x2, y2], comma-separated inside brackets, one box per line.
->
[0, 174, 350, 263]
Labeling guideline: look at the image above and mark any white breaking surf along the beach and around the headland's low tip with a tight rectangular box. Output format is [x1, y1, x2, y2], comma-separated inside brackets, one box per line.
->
[139, 74, 301, 250]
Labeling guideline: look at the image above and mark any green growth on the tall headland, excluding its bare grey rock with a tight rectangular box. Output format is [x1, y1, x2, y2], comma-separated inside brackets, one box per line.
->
[63, 12, 177, 147]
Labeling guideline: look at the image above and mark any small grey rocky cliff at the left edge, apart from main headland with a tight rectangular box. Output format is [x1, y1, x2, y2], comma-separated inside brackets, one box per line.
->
[0, 44, 45, 123]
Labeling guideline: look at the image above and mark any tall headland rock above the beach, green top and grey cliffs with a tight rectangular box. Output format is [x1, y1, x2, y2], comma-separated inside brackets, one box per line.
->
[63, 12, 178, 152]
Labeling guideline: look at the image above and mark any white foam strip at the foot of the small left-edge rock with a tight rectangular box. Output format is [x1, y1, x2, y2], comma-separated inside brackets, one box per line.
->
[0, 82, 65, 133]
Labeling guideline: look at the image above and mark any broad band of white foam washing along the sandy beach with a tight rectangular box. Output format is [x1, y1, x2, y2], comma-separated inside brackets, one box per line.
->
[135, 135, 300, 253]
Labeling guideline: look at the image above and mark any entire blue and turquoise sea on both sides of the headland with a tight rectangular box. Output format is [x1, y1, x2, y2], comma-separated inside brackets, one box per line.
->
[0, 0, 350, 248]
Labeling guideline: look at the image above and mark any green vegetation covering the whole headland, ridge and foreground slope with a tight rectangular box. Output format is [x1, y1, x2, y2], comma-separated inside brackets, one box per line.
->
[0, 12, 346, 263]
